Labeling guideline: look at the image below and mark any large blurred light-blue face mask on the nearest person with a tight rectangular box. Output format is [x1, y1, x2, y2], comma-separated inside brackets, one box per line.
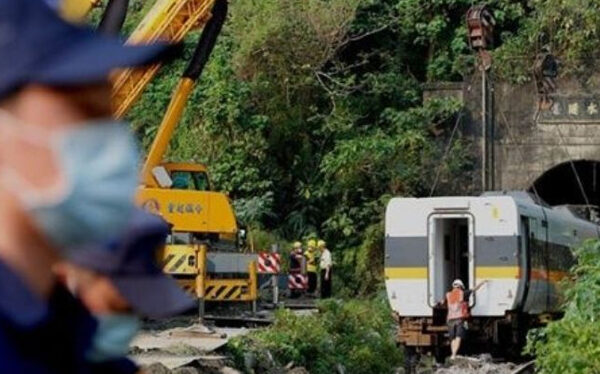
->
[3, 120, 139, 249]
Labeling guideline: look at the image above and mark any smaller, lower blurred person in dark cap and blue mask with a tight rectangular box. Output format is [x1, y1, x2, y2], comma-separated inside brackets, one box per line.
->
[55, 211, 195, 374]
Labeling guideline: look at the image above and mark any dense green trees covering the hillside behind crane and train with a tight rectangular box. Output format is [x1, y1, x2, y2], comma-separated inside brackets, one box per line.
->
[113, 0, 600, 293]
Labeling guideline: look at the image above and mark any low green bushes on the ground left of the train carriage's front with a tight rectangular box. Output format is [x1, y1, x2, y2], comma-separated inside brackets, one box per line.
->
[227, 298, 402, 374]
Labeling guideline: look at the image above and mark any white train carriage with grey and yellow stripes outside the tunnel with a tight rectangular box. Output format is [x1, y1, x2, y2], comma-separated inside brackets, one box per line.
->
[385, 192, 599, 358]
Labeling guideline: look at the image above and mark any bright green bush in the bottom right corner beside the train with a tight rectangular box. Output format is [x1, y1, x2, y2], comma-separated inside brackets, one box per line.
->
[527, 241, 600, 374]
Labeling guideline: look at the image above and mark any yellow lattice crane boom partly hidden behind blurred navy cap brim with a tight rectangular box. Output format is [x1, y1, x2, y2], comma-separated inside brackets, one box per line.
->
[113, 0, 215, 117]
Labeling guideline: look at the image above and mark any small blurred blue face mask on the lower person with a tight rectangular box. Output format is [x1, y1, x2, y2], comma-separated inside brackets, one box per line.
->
[86, 314, 140, 362]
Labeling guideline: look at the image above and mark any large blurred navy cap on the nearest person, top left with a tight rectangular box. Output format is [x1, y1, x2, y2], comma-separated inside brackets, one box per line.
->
[0, 0, 172, 98]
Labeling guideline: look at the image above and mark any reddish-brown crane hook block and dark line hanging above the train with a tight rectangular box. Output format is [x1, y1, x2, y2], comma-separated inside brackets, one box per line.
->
[466, 5, 496, 191]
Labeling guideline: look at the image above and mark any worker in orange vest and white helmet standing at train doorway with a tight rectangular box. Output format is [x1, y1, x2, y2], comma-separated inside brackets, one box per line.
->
[442, 279, 487, 360]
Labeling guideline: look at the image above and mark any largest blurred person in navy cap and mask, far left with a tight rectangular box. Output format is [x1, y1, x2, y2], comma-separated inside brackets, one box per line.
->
[0, 0, 168, 374]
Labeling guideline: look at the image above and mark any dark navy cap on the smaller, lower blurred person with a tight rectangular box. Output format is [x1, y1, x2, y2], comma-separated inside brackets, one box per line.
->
[69, 210, 195, 318]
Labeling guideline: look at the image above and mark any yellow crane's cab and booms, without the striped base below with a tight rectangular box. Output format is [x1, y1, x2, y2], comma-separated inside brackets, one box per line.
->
[113, 0, 238, 243]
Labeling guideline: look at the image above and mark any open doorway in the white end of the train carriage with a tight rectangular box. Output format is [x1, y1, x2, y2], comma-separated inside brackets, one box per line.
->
[428, 214, 475, 306]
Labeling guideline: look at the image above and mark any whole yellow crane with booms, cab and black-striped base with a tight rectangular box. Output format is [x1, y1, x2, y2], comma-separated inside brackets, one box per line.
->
[63, 0, 257, 310]
